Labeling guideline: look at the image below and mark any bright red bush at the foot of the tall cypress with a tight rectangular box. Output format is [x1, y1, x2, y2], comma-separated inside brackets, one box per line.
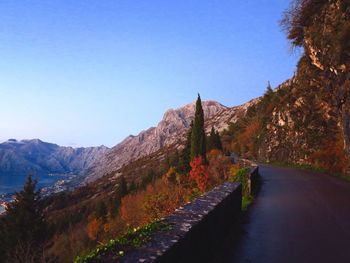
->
[190, 156, 209, 192]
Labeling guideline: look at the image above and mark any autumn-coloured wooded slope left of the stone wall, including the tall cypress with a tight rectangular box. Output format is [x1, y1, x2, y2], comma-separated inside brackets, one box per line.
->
[0, 97, 249, 262]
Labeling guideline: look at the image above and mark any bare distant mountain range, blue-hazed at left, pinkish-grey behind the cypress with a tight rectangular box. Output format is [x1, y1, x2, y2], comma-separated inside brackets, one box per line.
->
[0, 98, 259, 186]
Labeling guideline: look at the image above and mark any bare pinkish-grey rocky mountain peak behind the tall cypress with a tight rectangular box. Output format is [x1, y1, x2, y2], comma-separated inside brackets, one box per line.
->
[85, 101, 255, 181]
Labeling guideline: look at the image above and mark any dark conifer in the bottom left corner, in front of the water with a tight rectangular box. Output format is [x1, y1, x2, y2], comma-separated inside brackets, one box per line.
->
[0, 175, 48, 262]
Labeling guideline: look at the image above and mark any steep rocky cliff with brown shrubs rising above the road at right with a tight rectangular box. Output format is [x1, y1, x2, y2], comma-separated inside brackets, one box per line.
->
[230, 0, 350, 174]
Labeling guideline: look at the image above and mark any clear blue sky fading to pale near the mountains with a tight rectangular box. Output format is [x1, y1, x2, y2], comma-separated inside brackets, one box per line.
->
[0, 0, 298, 146]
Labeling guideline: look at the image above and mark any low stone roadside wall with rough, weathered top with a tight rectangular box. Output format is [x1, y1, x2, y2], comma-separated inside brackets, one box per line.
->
[121, 183, 242, 263]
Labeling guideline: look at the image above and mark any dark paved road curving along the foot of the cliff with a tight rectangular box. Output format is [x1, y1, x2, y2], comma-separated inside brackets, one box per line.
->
[224, 166, 350, 263]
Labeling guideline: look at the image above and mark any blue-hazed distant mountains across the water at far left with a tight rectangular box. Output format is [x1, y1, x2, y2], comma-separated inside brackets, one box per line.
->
[0, 139, 108, 176]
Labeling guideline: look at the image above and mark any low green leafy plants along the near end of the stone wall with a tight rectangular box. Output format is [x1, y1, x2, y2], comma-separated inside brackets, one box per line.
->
[74, 221, 171, 263]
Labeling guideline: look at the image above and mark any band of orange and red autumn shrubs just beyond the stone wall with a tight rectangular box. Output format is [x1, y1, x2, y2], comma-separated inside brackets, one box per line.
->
[87, 150, 232, 241]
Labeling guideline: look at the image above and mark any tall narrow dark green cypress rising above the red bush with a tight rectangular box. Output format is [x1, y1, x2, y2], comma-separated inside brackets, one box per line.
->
[191, 94, 207, 162]
